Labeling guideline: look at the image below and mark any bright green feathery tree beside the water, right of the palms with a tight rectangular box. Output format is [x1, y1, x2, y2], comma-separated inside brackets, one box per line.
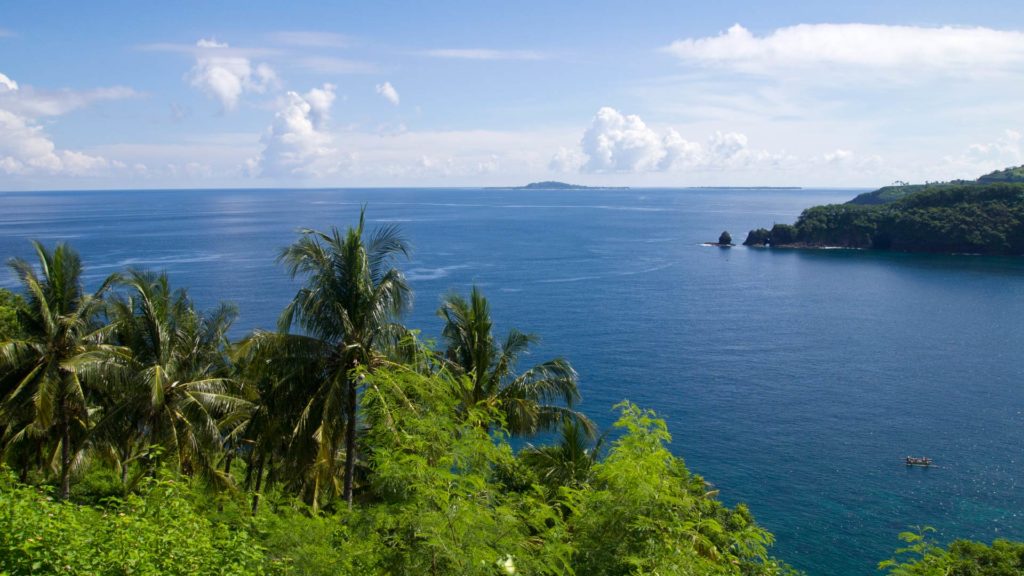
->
[567, 403, 788, 576]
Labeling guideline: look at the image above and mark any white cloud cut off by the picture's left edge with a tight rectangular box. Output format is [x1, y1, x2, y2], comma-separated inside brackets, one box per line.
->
[0, 74, 120, 175]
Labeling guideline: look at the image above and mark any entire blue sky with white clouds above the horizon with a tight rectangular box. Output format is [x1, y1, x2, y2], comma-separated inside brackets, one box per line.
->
[0, 0, 1024, 191]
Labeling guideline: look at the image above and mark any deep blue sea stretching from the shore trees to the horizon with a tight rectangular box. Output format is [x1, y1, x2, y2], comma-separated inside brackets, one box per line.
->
[0, 189, 1024, 575]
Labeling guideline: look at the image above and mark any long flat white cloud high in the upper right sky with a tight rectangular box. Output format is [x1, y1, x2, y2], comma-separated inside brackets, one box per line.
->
[665, 24, 1024, 74]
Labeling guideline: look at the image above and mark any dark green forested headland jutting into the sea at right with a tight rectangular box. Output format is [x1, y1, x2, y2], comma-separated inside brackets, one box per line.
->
[743, 166, 1024, 255]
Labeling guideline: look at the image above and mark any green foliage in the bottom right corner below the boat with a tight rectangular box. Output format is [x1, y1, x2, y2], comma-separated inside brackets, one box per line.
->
[879, 527, 1024, 576]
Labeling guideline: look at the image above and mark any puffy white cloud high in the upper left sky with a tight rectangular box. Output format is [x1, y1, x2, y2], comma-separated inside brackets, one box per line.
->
[188, 39, 278, 112]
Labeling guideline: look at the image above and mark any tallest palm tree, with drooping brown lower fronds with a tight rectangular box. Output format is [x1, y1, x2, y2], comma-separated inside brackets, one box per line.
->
[247, 208, 412, 506]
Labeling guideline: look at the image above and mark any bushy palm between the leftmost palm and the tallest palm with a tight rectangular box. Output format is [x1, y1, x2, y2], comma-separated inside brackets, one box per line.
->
[95, 271, 245, 481]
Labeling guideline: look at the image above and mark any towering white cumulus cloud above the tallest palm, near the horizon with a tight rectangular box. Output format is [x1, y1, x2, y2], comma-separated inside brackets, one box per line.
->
[247, 84, 340, 178]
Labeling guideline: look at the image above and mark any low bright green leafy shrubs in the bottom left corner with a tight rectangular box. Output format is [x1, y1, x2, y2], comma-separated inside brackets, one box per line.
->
[0, 470, 268, 576]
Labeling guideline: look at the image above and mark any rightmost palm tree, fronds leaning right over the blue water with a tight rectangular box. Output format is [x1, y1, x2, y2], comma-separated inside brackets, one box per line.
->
[437, 286, 594, 435]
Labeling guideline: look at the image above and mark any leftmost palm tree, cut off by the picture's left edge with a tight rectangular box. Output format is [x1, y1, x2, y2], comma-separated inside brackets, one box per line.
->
[0, 242, 120, 499]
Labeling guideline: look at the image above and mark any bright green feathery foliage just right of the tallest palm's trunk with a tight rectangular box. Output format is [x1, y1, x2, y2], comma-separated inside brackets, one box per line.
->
[361, 368, 571, 575]
